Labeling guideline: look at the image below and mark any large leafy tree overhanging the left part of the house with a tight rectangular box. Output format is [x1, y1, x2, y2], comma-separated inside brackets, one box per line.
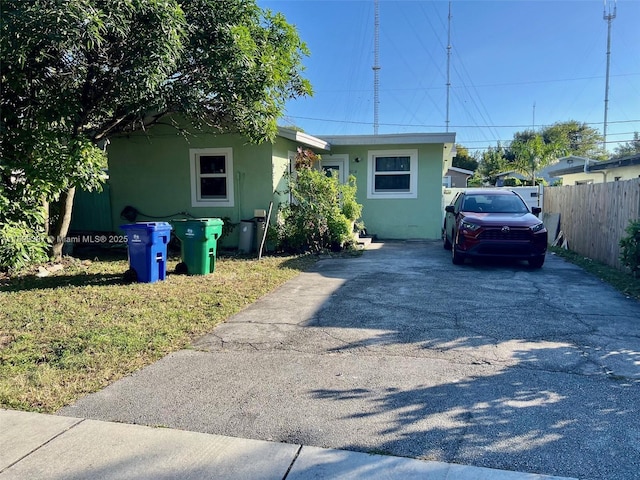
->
[0, 0, 311, 262]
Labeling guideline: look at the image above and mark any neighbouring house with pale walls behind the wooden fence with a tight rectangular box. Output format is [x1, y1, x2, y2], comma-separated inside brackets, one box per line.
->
[549, 154, 640, 185]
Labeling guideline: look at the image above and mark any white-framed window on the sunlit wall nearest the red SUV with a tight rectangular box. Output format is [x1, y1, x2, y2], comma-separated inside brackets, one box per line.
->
[367, 150, 418, 198]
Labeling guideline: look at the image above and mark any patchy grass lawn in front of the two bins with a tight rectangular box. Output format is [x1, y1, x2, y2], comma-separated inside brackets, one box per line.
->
[0, 248, 316, 412]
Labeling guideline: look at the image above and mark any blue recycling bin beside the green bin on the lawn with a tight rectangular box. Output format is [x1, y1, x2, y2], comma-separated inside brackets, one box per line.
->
[120, 222, 171, 283]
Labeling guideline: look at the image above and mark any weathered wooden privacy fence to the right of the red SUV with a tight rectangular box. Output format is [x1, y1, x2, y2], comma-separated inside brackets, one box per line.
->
[544, 178, 640, 269]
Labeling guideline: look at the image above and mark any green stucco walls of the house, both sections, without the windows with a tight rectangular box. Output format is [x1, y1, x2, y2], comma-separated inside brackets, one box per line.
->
[108, 127, 443, 246]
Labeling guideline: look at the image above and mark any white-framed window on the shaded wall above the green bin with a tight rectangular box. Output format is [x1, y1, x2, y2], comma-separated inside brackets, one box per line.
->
[189, 148, 233, 207]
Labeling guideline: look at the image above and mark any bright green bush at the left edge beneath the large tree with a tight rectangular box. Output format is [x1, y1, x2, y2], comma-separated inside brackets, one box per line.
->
[0, 222, 49, 272]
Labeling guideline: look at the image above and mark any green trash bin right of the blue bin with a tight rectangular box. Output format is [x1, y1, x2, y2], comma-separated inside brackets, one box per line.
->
[171, 218, 224, 275]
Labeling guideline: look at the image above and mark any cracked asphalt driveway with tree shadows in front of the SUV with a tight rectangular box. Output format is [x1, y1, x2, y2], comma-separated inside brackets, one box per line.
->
[59, 242, 640, 480]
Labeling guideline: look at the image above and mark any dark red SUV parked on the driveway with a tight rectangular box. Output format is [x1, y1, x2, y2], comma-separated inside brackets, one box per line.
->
[442, 188, 547, 268]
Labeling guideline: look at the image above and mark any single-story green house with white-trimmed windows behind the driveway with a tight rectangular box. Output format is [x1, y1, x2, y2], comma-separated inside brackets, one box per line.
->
[108, 125, 455, 246]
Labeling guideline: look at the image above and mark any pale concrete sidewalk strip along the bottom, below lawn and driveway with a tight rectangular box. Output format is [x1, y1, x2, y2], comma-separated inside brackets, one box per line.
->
[0, 409, 576, 480]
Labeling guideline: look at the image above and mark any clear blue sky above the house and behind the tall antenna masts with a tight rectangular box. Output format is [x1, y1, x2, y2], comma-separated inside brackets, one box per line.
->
[258, 0, 640, 152]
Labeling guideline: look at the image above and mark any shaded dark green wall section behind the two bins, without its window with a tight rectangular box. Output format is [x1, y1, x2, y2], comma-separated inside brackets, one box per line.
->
[108, 127, 274, 245]
